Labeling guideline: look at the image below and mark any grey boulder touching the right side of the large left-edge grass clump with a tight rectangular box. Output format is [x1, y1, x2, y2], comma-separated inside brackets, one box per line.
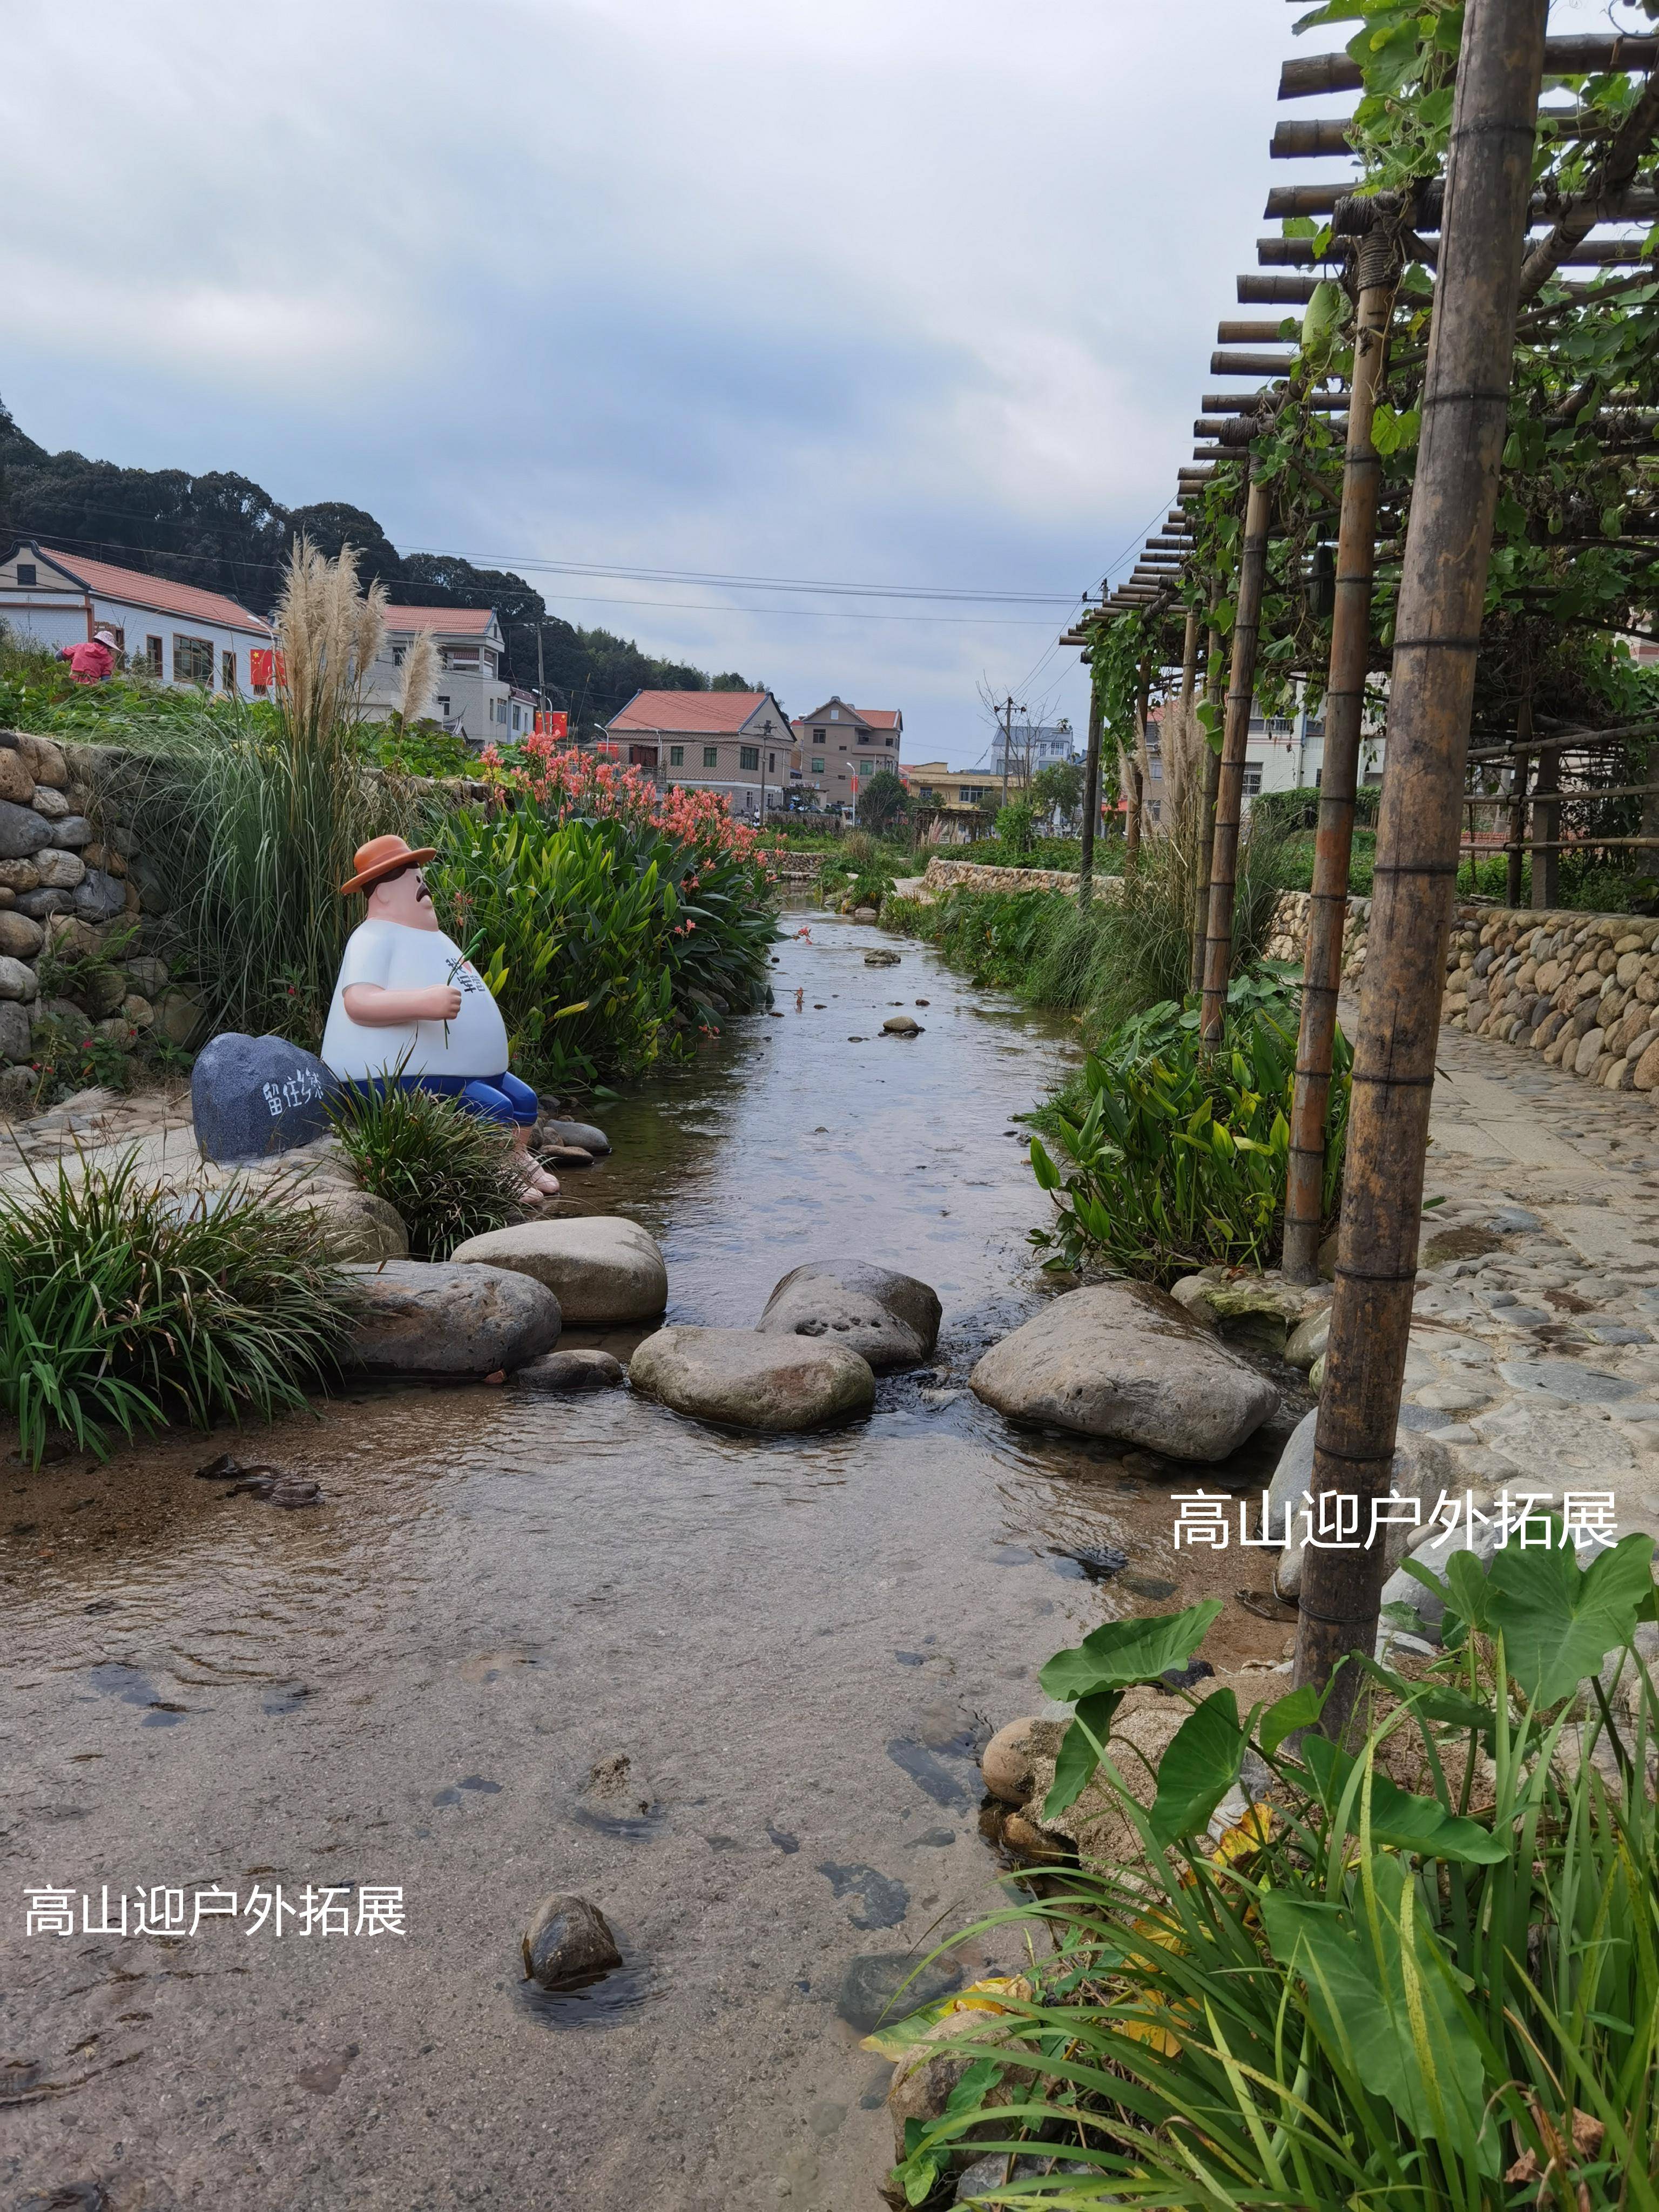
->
[345, 1259, 559, 1376]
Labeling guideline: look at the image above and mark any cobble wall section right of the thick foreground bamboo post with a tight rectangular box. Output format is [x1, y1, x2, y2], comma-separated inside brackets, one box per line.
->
[1442, 907, 1659, 1090]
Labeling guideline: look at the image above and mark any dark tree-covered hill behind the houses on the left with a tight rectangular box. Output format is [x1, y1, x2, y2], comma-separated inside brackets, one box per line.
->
[0, 405, 750, 728]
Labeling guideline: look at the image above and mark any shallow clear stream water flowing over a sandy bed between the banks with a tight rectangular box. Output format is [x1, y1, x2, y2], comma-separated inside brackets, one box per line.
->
[0, 914, 1285, 2212]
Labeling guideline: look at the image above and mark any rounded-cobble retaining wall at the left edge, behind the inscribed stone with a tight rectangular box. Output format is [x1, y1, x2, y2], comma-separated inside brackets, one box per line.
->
[0, 730, 201, 1110]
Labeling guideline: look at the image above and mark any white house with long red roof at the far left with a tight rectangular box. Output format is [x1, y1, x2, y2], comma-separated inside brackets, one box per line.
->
[0, 537, 270, 694]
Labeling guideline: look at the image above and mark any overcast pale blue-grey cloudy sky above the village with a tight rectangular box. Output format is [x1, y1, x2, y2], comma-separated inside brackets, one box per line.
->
[0, 0, 1415, 765]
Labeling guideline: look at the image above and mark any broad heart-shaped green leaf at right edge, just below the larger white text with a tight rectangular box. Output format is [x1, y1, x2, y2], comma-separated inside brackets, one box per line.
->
[1478, 1520, 1653, 1705]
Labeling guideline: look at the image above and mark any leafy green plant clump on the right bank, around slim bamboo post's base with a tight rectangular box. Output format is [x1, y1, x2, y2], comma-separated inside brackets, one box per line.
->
[1031, 973, 1352, 1283]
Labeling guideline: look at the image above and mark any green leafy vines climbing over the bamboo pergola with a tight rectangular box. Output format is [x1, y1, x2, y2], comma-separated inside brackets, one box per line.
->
[1159, 0, 1659, 728]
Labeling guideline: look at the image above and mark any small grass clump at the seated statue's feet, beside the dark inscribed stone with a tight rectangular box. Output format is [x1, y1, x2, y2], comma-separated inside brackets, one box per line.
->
[327, 1082, 524, 1259]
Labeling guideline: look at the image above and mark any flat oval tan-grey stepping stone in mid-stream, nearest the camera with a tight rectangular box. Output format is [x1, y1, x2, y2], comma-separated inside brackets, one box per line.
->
[628, 1327, 876, 1431]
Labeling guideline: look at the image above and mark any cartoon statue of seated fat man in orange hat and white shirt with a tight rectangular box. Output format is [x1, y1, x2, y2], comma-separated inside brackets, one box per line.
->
[323, 836, 559, 1205]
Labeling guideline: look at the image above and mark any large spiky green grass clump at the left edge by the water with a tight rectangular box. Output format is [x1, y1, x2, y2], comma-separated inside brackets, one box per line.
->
[0, 1152, 352, 1467]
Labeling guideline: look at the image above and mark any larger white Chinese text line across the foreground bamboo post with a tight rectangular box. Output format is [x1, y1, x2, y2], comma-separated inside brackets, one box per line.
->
[1175, 1491, 1619, 1553]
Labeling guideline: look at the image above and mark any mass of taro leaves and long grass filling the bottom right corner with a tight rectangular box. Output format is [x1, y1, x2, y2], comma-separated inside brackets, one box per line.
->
[880, 1522, 1659, 2212]
